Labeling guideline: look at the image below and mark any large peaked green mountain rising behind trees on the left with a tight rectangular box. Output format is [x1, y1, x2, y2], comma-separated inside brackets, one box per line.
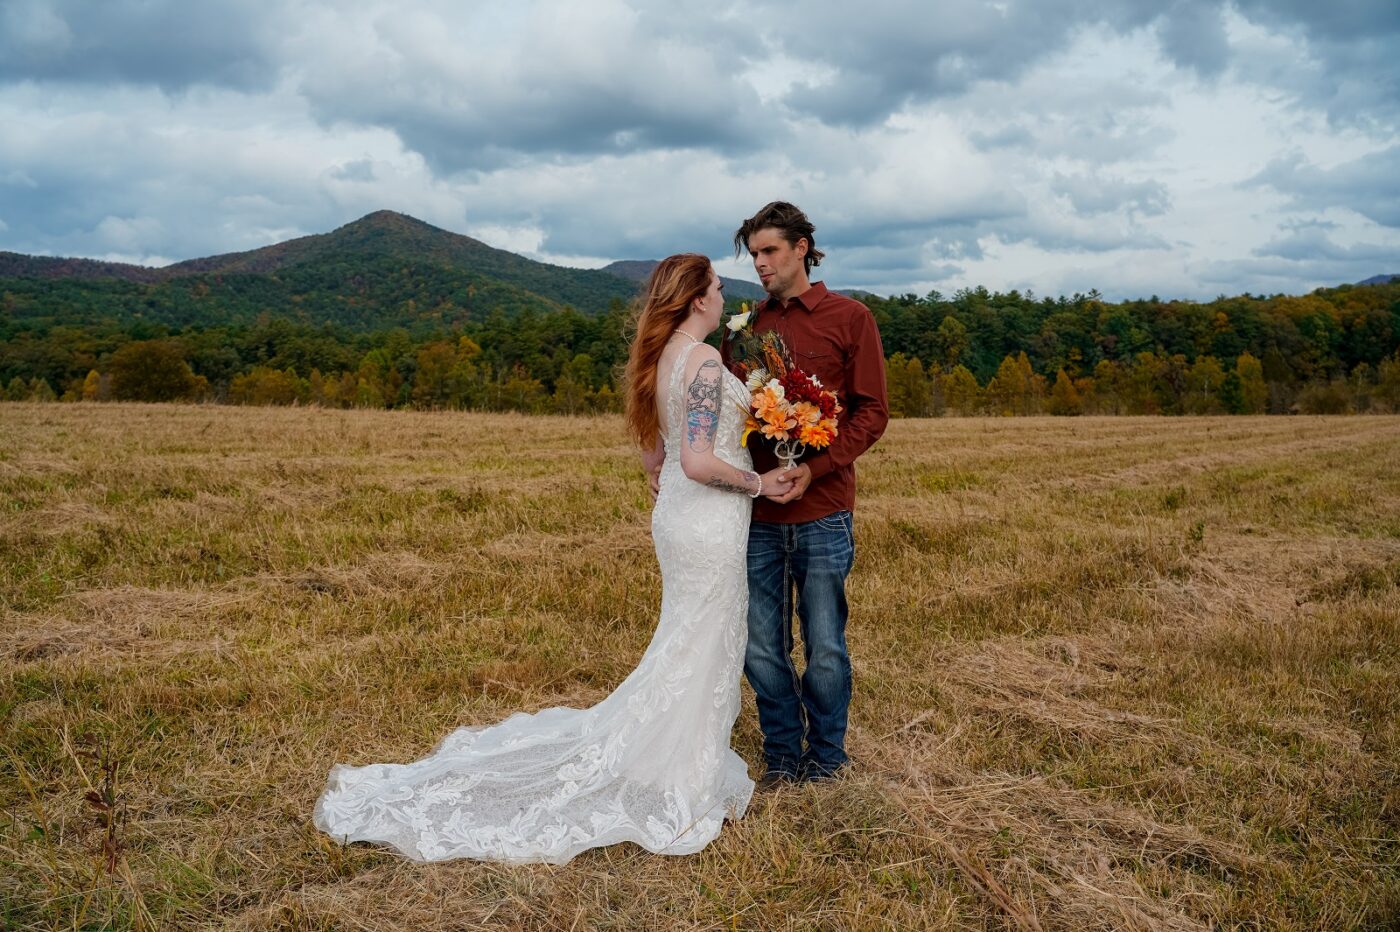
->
[0, 210, 637, 332]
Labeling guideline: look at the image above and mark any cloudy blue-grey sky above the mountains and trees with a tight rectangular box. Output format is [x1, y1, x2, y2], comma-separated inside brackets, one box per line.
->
[0, 0, 1400, 299]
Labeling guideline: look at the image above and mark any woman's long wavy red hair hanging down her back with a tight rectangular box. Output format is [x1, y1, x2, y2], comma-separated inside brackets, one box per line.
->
[626, 252, 714, 449]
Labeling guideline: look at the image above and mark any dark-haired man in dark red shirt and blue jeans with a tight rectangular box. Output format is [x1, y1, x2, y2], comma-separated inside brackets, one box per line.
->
[722, 200, 889, 789]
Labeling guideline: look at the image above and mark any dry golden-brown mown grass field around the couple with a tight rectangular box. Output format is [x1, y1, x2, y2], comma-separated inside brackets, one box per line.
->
[0, 403, 1400, 929]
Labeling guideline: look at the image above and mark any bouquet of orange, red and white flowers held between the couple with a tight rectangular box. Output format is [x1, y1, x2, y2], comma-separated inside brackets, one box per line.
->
[725, 304, 841, 469]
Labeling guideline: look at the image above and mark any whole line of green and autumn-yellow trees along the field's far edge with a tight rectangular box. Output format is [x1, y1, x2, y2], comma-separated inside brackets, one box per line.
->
[0, 284, 1400, 417]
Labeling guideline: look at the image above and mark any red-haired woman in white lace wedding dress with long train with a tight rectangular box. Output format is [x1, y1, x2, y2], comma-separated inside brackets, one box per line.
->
[315, 255, 785, 863]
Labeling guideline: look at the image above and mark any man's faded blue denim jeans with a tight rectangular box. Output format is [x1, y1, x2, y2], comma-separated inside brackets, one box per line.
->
[743, 511, 855, 778]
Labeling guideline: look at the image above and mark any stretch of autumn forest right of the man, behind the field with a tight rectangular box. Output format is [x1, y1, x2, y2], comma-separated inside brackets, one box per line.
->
[865, 284, 1400, 414]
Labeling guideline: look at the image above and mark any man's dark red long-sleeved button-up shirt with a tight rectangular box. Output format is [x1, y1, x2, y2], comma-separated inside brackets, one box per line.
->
[721, 281, 889, 525]
